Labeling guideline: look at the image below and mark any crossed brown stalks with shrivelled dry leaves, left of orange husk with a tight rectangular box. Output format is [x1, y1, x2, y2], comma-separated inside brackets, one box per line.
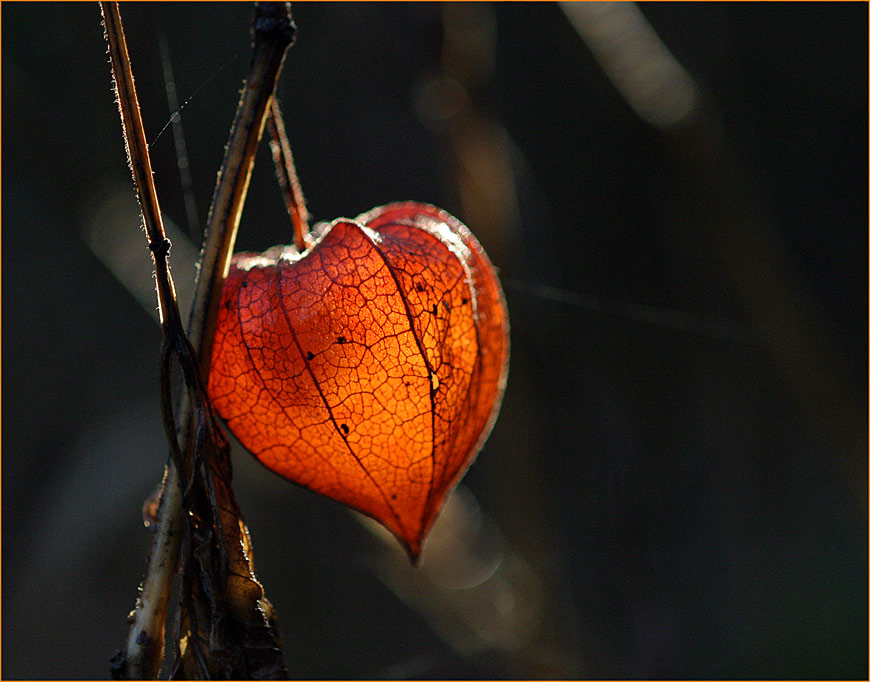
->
[101, 3, 294, 679]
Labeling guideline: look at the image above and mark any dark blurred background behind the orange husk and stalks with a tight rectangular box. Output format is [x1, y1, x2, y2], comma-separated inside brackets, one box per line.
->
[2, 3, 868, 679]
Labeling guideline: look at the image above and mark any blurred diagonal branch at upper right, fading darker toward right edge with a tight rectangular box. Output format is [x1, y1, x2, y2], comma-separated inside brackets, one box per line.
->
[560, 2, 868, 510]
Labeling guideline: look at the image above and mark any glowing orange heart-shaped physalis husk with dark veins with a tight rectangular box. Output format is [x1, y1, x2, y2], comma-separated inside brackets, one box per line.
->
[209, 202, 508, 561]
